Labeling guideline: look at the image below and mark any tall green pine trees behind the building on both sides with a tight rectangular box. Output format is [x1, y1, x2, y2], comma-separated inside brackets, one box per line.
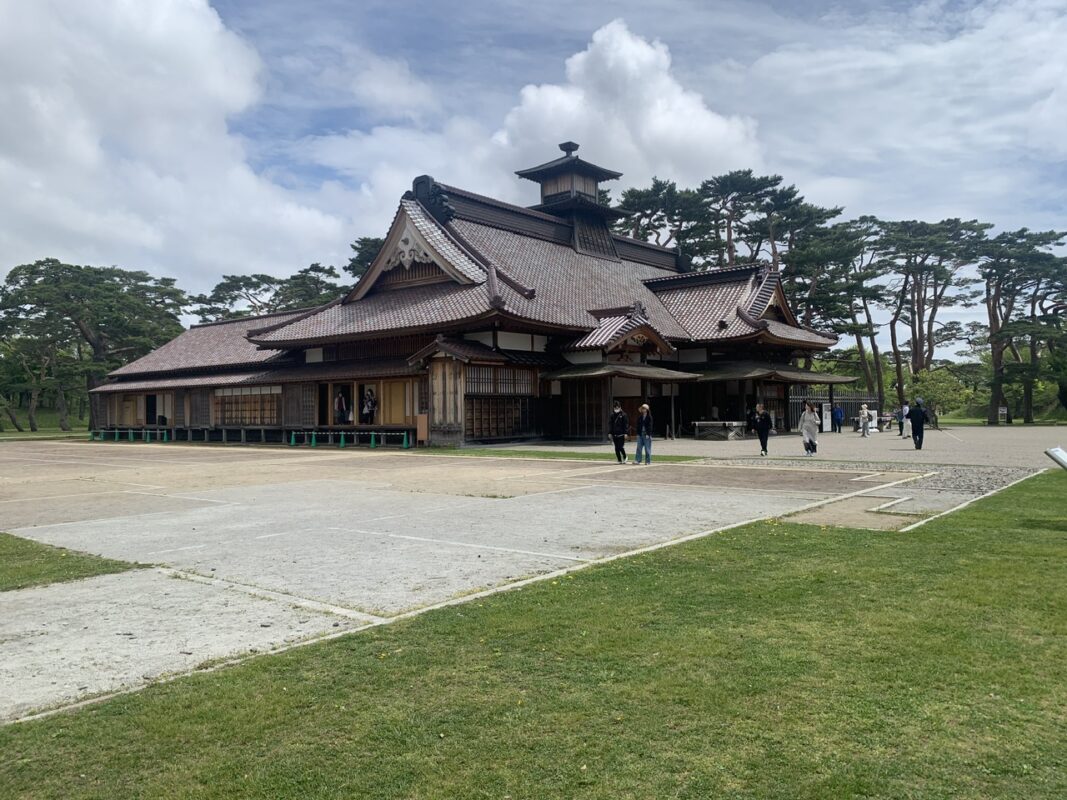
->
[6, 170, 1067, 430]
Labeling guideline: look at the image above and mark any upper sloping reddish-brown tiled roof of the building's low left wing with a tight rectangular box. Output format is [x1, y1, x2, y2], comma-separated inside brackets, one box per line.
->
[111, 309, 307, 377]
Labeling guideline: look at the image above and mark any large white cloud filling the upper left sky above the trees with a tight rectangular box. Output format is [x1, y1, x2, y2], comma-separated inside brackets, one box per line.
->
[0, 0, 345, 289]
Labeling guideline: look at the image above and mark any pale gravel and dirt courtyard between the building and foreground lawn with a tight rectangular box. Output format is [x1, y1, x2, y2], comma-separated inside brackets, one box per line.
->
[0, 442, 1041, 720]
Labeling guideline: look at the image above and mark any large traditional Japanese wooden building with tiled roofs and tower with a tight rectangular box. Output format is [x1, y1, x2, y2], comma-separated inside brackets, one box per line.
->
[93, 142, 851, 444]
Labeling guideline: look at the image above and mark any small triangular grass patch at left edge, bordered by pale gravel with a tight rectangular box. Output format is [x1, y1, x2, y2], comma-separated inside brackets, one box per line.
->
[0, 533, 140, 593]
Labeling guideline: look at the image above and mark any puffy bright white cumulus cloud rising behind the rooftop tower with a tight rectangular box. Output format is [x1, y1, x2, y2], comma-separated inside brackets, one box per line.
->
[293, 20, 762, 229]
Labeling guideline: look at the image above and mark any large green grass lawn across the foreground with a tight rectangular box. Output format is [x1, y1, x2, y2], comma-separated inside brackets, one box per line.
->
[0, 471, 1067, 800]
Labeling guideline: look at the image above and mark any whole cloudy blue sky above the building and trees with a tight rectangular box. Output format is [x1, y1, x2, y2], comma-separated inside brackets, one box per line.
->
[0, 0, 1067, 300]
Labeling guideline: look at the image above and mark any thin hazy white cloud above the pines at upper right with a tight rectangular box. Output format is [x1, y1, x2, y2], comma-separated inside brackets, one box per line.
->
[712, 0, 1067, 227]
